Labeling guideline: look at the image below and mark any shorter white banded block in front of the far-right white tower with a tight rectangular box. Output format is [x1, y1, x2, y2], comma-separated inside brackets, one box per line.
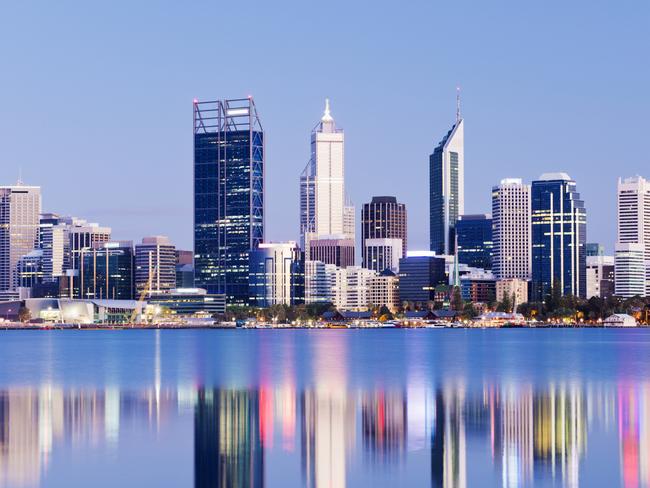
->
[614, 242, 646, 298]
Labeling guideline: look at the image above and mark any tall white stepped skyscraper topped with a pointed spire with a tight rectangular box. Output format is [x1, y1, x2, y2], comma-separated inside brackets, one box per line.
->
[300, 100, 355, 254]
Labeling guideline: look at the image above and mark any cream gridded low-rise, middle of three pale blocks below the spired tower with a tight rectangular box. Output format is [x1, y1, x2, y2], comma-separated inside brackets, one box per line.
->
[332, 266, 377, 312]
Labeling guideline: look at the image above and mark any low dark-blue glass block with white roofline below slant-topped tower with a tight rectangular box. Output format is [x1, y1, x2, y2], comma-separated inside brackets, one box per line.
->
[399, 252, 446, 302]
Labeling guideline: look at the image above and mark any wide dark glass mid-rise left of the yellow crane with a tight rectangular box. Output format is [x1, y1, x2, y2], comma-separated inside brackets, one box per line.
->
[75, 241, 135, 300]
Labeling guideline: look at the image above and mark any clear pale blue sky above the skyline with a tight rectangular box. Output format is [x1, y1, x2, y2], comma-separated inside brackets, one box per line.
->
[0, 0, 650, 251]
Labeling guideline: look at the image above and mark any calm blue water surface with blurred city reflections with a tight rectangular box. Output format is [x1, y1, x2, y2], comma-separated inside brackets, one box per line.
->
[0, 329, 650, 488]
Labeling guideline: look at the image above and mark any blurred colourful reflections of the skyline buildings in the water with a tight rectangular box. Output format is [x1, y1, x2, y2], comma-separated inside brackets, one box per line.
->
[0, 384, 650, 488]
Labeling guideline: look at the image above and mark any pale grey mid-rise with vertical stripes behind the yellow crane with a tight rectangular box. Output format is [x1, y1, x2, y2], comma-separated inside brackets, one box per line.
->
[135, 236, 176, 297]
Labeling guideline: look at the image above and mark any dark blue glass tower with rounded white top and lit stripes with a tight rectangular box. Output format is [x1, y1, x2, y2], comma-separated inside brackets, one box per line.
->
[531, 173, 587, 301]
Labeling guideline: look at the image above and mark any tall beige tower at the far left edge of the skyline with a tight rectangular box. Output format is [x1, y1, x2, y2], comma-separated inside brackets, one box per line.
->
[0, 182, 41, 291]
